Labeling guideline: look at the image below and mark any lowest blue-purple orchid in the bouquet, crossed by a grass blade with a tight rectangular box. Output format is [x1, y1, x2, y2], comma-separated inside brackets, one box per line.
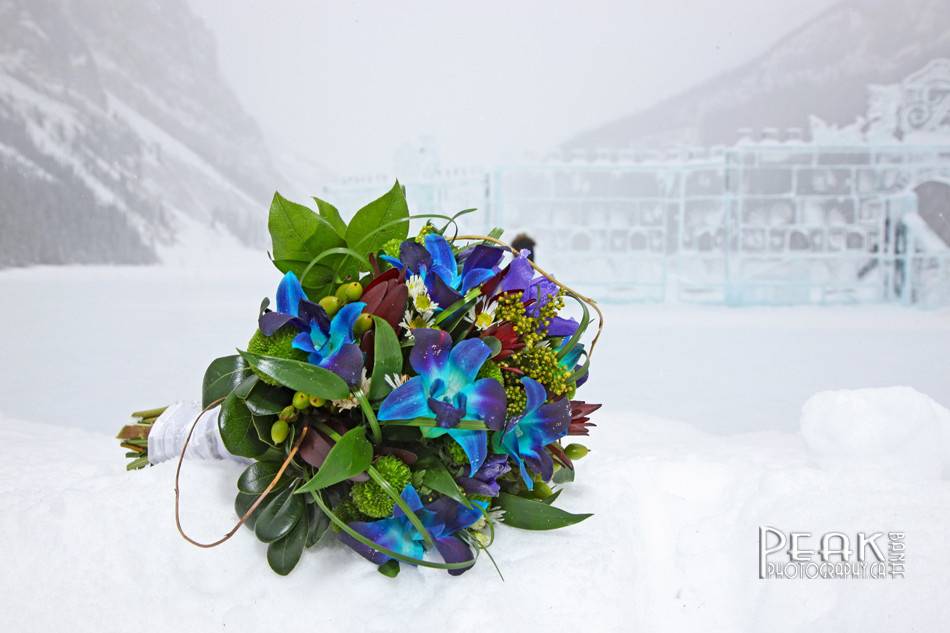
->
[339, 484, 488, 576]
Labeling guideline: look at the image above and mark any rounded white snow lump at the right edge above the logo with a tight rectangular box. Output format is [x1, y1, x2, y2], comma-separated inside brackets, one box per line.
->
[801, 387, 950, 481]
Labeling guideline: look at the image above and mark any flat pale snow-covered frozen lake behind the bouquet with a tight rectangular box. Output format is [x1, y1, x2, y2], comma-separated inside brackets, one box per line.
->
[0, 256, 950, 433]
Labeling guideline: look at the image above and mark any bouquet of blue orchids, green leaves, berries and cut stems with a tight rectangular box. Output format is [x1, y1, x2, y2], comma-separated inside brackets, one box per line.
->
[120, 183, 603, 576]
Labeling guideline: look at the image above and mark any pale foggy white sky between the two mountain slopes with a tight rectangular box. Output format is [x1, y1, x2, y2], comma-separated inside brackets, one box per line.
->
[189, 0, 832, 175]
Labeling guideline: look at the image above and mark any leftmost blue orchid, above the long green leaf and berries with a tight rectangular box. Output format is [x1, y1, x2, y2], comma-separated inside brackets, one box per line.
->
[292, 301, 366, 387]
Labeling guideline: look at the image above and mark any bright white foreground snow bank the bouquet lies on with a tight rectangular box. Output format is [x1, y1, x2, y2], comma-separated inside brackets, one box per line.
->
[0, 409, 950, 633]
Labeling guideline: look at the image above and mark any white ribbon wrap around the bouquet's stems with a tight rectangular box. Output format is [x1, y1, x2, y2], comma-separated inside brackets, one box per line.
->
[148, 402, 250, 465]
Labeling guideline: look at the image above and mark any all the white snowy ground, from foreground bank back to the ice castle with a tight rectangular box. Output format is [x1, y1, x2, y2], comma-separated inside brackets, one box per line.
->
[0, 264, 950, 632]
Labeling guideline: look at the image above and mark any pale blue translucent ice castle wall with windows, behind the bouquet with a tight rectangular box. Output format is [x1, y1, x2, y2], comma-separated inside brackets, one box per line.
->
[325, 59, 950, 306]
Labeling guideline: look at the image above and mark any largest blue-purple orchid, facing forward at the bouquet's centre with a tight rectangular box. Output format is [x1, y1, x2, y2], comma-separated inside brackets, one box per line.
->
[377, 328, 506, 476]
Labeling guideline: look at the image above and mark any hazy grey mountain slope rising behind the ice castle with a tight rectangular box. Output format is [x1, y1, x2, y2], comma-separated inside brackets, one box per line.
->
[565, 0, 950, 148]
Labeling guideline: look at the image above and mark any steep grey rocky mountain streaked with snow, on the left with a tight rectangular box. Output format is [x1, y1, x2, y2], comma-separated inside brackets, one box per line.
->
[0, 0, 308, 267]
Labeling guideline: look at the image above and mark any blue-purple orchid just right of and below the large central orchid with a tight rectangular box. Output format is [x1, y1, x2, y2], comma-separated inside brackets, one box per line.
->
[495, 376, 571, 490]
